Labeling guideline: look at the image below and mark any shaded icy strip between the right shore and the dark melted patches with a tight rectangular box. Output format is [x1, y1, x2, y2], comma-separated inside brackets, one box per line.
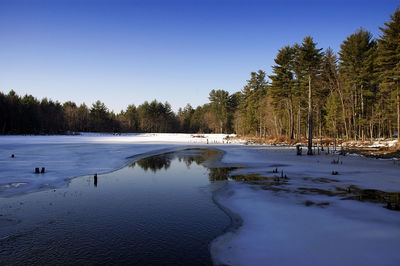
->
[217, 146, 400, 192]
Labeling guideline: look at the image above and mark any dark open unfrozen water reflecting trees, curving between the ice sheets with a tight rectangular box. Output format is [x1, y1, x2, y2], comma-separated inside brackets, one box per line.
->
[0, 150, 230, 265]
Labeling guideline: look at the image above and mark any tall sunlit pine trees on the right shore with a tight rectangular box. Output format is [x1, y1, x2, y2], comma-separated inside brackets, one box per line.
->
[245, 9, 400, 139]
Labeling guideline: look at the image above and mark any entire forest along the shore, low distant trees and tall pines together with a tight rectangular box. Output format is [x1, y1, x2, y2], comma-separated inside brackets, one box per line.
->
[0, 8, 400, 139]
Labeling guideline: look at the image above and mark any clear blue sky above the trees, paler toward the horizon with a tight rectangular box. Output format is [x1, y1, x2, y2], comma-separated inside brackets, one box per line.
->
[0, 0, 400, 112]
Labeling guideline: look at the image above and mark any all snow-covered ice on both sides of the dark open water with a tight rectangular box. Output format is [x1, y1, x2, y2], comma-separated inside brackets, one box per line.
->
[0, 134, 400, 265]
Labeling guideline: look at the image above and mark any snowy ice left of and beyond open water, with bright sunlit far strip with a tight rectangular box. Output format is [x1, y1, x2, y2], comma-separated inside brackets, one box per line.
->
[0, 133, 238, 197]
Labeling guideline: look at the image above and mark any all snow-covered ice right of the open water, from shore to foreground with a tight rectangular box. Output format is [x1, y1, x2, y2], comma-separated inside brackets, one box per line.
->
[211, 147, 400, 265]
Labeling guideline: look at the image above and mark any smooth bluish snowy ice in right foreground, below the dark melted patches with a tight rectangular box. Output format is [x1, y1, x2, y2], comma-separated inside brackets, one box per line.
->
[211, 183, 400, 266]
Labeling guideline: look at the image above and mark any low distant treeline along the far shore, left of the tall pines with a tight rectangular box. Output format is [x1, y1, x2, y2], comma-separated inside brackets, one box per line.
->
[0, 90, 237, 134]
